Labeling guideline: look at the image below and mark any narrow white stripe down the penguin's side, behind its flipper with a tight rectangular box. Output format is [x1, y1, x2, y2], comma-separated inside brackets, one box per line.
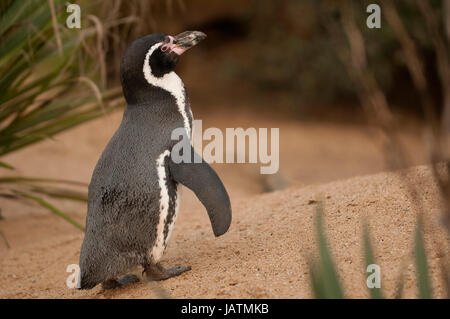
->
[150, 150, 181, 263]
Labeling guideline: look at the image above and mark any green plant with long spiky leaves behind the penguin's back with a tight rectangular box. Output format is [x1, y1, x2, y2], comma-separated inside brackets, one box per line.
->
[0, 0, 121, 229]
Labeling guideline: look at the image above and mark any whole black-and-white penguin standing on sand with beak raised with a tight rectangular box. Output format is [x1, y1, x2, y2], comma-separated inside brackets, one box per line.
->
[78, 31, 231, 289]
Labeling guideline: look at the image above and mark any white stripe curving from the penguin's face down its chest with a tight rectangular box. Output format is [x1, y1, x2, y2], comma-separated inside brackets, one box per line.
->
[143, 42, 191, 136]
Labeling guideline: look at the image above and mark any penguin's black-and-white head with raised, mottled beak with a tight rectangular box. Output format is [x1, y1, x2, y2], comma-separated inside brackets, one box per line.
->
[120, 31, 206, 100]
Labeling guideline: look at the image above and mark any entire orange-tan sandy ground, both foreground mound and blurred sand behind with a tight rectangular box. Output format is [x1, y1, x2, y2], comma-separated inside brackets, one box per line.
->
[0, 110, 449, 298]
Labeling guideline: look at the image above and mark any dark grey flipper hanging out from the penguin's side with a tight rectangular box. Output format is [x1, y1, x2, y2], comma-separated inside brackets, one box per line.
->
[169, 147, 231, 237]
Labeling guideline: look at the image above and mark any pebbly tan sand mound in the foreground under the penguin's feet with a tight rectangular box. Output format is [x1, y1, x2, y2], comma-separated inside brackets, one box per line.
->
[0, 166, 450, 298]
